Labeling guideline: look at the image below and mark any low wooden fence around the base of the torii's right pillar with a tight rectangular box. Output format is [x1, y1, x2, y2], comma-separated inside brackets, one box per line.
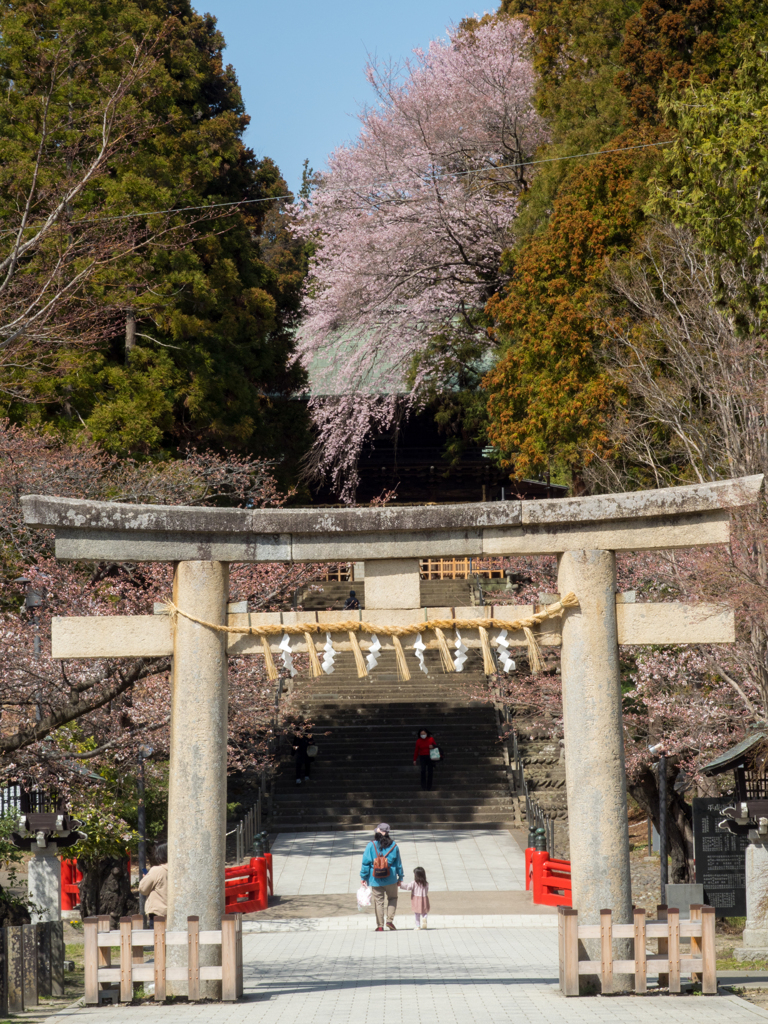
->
[557, 903, 718, 995]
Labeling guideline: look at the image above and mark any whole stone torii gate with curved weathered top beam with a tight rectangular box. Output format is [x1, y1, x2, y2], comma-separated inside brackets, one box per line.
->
[22, 476, 763, 983]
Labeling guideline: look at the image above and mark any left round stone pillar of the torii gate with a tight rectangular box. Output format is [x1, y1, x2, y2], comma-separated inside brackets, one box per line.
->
[167, 561, 229, 998]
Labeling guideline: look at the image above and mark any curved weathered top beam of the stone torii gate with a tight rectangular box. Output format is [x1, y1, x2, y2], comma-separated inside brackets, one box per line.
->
[22, 475, 763, 562]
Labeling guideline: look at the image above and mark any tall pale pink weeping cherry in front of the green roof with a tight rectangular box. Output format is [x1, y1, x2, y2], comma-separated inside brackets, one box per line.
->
[295, 19, 547, 500]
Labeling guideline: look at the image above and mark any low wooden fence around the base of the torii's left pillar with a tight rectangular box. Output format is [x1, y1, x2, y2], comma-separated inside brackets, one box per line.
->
[83, 913, 243, 1006]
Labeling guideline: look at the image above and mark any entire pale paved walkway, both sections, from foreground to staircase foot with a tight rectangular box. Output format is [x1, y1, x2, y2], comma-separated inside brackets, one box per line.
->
[48, 831, 768, 1024]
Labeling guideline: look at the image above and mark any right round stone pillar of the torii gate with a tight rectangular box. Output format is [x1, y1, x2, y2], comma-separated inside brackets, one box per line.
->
[558, 550, 632, 990]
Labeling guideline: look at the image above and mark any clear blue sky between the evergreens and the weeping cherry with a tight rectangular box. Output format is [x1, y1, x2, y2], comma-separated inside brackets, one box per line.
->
[196, 0, 487, 188]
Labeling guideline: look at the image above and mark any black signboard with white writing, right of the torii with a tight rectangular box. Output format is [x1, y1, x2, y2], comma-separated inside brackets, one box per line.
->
[693, 797, 750, 918]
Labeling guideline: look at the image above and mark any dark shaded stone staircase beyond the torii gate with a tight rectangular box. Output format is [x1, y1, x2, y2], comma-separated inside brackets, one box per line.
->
[270, 651, 519, 833]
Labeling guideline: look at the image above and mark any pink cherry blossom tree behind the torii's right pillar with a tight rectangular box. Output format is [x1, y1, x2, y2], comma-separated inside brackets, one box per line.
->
[472, 548, 768, 882]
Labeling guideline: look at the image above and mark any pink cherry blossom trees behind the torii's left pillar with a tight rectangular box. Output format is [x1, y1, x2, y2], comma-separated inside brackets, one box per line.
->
[0, 424, 317, 792]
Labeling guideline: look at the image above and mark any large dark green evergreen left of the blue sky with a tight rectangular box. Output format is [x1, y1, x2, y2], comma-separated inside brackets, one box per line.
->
[2, 0, 306, 479]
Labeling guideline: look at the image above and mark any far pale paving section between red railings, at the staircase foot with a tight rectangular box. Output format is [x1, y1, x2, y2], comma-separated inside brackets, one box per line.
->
[272, 829, 525, 896]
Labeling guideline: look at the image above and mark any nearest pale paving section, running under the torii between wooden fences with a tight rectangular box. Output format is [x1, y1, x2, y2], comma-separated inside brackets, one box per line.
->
[49, 928, 768, 1024]
